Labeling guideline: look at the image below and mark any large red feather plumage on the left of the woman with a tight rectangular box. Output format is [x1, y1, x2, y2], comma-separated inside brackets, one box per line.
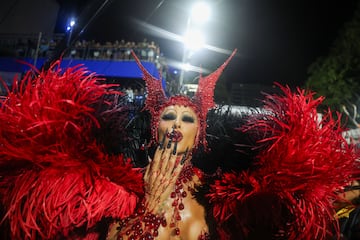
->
[0, 62, 143, 239]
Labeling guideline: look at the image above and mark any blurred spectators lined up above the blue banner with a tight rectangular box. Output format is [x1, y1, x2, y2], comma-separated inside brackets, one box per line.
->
[0, 35, 160, 62]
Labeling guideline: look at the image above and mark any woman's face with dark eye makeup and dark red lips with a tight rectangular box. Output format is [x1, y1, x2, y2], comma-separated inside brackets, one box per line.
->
[158, 105, 199, 154]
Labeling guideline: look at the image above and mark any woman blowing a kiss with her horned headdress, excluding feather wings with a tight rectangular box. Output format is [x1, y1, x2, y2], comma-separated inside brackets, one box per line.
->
[108, 51, 235, 240]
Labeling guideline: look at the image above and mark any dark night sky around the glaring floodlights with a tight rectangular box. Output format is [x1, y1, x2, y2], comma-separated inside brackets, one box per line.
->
[59, 0, 357, 86]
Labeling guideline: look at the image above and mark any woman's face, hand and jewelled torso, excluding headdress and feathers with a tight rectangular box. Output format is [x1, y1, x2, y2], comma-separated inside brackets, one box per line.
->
[109, 105, 208, 239]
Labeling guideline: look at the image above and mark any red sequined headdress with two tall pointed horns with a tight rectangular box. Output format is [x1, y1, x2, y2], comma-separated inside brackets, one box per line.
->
[132, 49, 236, 150]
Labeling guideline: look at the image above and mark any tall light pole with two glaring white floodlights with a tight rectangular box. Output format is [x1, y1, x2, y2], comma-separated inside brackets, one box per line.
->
[179, 1, 210, 90]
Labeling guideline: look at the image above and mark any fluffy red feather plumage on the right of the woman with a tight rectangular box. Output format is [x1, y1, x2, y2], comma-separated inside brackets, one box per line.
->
[208, 83, 359, 240]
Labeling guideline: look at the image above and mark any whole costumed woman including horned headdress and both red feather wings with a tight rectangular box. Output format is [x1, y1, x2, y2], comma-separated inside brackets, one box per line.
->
[0, 51, 359, 240]
